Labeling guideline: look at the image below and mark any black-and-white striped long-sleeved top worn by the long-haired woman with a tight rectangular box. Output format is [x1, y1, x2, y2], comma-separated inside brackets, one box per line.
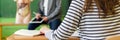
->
[46, 0, 120, 40]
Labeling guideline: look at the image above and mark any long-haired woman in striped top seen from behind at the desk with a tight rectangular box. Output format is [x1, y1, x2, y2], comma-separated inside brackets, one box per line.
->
[41, 0, 120, 40]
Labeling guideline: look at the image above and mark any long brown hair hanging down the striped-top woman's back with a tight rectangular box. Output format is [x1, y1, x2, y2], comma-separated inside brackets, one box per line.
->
[83, 0, 120, 18]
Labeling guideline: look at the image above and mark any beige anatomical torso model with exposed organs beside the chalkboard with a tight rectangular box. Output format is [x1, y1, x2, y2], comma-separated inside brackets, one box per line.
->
[14, 0, 33, 24]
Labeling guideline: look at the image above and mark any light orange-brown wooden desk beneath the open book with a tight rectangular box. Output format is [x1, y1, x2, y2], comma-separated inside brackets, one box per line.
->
[7, 34, 80, 40]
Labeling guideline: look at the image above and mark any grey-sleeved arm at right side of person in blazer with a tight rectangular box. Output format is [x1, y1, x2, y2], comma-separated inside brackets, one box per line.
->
[47, 0, 61, 20]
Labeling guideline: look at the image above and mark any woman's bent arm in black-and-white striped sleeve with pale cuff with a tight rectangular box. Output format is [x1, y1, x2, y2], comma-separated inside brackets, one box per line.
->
[45, 0, 83, 40]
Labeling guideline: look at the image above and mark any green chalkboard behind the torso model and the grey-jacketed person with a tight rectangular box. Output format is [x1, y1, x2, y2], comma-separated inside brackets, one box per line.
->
[0, 0, 69, 18]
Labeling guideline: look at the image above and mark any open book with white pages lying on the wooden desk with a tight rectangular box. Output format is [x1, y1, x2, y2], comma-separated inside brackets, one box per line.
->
[14, 29, 40, 36]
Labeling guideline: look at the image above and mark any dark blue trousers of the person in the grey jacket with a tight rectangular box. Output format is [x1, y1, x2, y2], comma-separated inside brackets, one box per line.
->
[28, 19, 61, 30]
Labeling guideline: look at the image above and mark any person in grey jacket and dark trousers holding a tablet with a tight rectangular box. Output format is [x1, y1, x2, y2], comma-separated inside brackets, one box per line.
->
[28, 0, 61, 30]
